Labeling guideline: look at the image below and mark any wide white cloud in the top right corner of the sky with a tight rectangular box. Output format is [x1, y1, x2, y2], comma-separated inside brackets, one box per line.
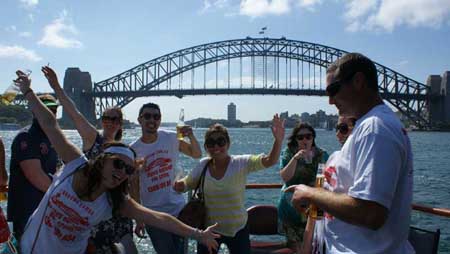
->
[345, 0, 450, 32]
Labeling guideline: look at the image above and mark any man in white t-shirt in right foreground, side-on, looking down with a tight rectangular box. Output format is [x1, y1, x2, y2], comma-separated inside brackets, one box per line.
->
[289, 53, 414, 254]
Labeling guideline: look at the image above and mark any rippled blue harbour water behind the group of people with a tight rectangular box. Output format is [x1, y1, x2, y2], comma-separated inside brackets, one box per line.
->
[0, 128, 450, 253]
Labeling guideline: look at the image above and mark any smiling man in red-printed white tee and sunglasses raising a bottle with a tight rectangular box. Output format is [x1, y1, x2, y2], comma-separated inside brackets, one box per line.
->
[131, 103, 202, 254]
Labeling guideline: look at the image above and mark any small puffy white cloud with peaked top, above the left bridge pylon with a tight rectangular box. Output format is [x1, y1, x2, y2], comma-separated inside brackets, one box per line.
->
[38, 10, 83, 48]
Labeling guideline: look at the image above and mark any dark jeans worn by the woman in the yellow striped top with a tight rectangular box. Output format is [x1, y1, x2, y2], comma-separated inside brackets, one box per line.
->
[197, 225, 250, 254]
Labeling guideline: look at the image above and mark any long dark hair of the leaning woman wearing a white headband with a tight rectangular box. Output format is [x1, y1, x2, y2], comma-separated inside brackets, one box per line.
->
[81, 142, 136, 215]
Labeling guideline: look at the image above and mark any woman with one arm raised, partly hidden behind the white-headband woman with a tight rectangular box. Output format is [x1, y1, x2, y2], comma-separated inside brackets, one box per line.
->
[42, 66, 137, 254]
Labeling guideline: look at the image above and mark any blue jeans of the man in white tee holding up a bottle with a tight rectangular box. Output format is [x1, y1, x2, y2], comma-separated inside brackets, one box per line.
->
[145, 226, 184, 254]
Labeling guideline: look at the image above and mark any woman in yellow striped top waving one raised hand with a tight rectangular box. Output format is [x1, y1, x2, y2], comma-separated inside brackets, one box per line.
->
[174, 115, 284, 254]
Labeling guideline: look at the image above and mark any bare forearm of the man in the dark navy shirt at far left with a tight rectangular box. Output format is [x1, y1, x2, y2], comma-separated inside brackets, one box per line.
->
[19, 159, 52, 192]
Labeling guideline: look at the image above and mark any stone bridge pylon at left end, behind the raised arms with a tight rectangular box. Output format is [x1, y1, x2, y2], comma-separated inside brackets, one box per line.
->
[62, 68, 97, 128]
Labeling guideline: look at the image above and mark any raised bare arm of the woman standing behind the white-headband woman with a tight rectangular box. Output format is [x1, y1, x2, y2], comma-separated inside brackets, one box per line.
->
[42, 66, 97, 151]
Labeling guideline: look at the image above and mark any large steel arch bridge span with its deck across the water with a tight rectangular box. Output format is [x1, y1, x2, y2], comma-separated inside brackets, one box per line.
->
[91, 37, 431, 128]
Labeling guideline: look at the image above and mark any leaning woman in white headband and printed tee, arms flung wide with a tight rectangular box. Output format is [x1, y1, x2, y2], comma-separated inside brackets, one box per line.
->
[15, 71, 218, 254]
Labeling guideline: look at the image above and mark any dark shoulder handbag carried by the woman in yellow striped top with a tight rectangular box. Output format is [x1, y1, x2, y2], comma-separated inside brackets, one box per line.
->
[178, 161, 209, 229]
